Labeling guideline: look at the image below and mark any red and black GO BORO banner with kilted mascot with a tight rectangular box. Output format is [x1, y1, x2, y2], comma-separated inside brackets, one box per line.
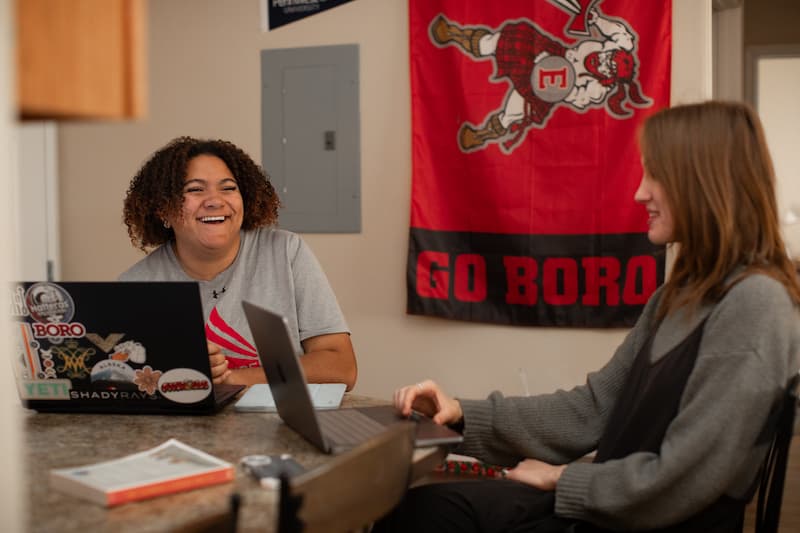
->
[408, 0, 672, 327]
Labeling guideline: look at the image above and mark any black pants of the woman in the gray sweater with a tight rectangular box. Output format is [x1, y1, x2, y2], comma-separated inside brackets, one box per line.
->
[373, 479, 575, 533]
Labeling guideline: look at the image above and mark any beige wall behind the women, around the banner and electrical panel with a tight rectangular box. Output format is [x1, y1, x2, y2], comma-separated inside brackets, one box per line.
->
[54, 0, 711, 397]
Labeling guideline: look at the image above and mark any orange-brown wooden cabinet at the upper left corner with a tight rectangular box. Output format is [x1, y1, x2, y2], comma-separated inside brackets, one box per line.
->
[15, 0, 147, 119]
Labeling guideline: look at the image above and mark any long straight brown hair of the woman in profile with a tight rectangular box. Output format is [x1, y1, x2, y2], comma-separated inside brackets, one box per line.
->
[639, 101, 800, 318]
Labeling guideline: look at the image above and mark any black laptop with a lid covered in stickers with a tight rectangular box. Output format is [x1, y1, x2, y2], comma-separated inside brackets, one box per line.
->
[10, 281, 244, 415]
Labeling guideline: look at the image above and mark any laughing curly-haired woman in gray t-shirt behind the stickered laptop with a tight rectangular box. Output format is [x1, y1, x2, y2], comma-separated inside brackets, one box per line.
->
[120, 137, 357, 390]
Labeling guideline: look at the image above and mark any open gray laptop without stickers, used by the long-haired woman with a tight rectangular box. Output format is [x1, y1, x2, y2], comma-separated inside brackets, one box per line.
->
[242, 301, 463, 453]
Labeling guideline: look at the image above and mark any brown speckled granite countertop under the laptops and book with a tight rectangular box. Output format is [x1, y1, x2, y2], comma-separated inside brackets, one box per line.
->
[23, 394, 396, 533]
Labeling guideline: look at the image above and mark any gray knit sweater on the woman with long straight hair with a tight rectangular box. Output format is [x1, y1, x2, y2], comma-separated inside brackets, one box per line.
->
[457, 275, 800, 529]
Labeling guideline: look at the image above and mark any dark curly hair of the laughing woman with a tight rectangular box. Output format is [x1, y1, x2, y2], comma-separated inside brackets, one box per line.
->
[122, 137, 281, 251]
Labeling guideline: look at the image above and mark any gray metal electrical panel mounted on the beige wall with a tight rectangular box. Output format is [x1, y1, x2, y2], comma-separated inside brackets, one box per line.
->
[261, 44, 361, 233]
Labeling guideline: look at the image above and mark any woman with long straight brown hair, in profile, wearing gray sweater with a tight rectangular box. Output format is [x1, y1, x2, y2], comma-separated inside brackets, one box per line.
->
[376, 102, 800, 532]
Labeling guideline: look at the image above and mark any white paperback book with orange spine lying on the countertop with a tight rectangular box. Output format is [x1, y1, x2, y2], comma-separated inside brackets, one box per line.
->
[50, 439, 235, 507]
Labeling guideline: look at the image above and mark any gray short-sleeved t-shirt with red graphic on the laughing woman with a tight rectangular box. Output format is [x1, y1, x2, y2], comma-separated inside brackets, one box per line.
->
[119, 228, 349, 368]
